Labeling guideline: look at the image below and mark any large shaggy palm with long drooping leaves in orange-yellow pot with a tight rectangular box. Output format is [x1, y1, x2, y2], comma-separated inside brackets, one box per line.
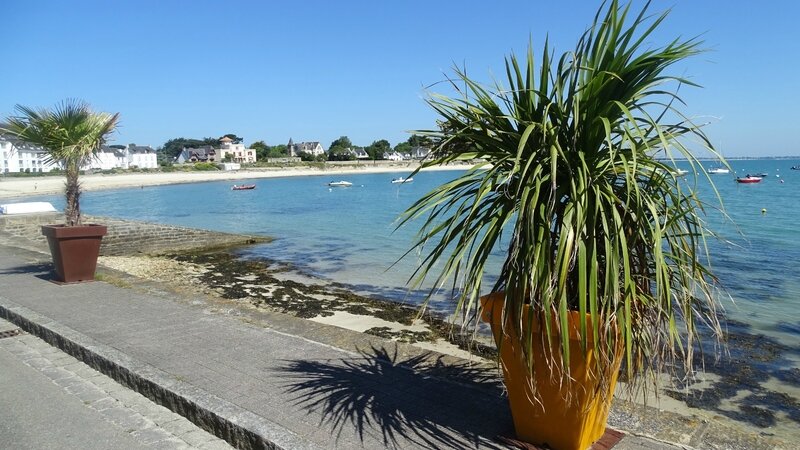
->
[399, 0, 721, 449]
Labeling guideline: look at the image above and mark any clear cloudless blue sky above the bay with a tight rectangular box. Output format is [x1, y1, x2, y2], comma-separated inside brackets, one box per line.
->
[0, 0, 800, 156]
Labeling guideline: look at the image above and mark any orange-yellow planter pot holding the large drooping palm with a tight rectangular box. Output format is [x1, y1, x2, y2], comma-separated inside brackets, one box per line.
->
[481, 293, 622, 450]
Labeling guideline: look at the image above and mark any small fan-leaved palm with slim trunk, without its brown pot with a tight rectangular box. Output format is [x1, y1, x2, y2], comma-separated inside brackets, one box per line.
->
[0, 99, 119, 226]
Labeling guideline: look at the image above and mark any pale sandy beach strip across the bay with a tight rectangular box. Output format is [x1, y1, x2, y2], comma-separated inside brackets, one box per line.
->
[0, 162, 470, 199]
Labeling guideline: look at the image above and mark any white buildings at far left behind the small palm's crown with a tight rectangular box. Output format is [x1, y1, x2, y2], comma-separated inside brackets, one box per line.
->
[0, 136, 158, 173]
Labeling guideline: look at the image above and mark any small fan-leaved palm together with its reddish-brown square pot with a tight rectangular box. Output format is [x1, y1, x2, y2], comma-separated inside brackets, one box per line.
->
[0, 99, 119, 283]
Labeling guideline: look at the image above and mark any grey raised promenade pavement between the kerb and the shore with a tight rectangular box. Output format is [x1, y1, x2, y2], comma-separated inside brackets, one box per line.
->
[0, 244, 775, 450]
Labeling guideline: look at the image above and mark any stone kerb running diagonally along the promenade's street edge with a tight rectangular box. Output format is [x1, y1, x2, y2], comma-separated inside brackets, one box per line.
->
[0, 296, 319, 450]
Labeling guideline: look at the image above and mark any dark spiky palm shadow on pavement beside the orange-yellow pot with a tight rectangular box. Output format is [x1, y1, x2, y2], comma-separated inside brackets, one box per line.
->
[281, 346, 513, 448]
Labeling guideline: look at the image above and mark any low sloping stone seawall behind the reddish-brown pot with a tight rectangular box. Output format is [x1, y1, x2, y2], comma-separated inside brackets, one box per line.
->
[0, 213, 270, 256]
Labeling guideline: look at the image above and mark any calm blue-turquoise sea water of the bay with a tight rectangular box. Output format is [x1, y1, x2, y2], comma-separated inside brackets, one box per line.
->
[15, 160, 800, 366]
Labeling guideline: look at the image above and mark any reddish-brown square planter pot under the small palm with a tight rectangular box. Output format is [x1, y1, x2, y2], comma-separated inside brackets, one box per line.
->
[42, 224, 108, 283]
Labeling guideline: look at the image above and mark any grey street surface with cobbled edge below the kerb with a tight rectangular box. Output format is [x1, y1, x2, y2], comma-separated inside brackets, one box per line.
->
[0, 320, 231, 450]
